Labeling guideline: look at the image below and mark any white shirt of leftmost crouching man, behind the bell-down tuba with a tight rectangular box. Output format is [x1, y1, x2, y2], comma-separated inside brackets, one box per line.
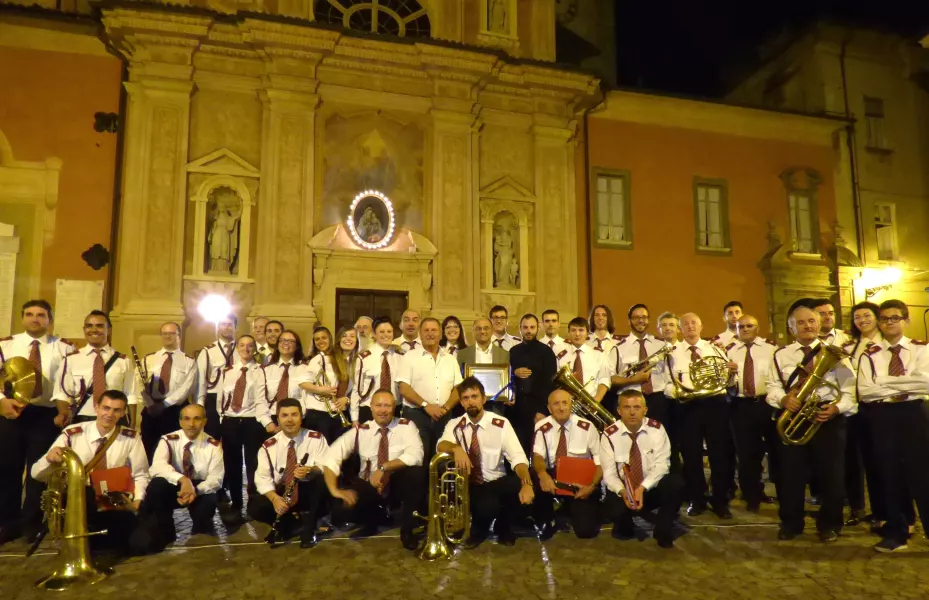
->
[30, 421, 150, 500]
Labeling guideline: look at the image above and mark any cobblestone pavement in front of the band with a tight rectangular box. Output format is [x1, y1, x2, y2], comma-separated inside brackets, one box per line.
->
[0, 502, 929, 600]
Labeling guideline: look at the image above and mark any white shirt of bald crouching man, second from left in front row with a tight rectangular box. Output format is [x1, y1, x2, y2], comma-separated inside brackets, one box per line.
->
[149, 429, 226, 494]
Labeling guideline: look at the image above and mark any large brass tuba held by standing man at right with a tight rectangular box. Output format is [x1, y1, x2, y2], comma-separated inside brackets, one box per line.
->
[777, 344, 849, 446]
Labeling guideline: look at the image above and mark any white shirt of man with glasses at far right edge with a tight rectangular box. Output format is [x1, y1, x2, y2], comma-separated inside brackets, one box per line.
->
[858, 336, 929, 404]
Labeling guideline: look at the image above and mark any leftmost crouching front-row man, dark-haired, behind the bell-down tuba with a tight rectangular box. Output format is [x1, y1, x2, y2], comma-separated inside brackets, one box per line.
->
[31, 390, 152, 555]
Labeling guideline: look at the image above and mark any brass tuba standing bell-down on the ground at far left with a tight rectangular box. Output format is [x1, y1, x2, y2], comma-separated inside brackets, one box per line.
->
[36, 448, 108, 590]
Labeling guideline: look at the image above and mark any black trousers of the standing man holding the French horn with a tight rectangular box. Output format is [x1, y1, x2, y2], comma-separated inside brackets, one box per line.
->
[678, 396, 732, 508]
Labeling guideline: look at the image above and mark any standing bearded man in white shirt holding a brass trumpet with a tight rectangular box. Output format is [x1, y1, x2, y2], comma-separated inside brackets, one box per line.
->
[597, 304, 671, 426]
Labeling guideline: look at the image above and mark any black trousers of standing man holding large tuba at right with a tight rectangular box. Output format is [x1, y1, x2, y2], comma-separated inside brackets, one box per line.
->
[777, 415, 846, 533]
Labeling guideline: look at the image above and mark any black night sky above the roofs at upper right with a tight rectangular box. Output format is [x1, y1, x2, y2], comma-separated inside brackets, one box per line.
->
[616, 0, 929, 97]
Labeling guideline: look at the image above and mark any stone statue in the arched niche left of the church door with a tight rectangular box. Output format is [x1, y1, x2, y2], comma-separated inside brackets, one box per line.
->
[204, 186, 242, 275]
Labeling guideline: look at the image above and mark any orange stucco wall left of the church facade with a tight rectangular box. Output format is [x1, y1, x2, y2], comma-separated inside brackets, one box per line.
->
[0, 46, 122, 302]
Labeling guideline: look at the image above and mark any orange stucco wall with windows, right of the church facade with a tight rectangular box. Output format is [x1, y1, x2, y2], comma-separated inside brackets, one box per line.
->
[578, 117, 835, 335]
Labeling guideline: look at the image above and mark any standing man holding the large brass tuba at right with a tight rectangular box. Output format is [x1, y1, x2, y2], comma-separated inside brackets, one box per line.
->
[766, 300, 856, 542]
